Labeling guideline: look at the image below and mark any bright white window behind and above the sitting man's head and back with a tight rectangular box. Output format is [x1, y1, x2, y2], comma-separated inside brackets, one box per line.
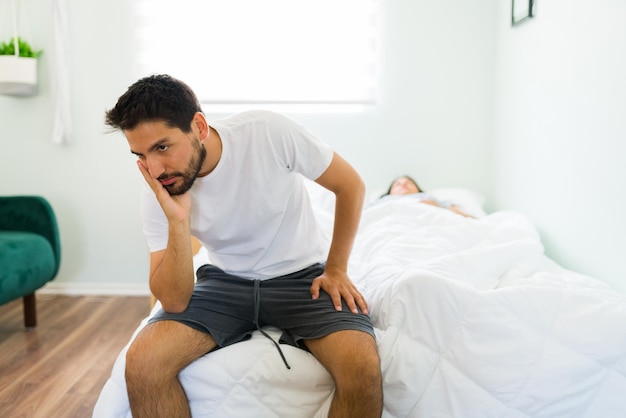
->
[135, 0, 377, 111]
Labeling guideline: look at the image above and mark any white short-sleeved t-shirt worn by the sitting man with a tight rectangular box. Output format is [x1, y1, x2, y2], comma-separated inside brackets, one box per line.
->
[141, 111, 333, 279]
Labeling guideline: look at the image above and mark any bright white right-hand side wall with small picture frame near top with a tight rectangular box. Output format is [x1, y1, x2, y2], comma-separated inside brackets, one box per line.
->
[494, 0, 626, 291]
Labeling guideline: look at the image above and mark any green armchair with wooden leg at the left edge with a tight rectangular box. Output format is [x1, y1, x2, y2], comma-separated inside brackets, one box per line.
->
[0, 196, 61, 328]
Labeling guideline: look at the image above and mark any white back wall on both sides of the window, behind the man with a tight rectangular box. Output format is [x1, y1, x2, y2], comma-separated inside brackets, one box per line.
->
[0, 0, 496, 292]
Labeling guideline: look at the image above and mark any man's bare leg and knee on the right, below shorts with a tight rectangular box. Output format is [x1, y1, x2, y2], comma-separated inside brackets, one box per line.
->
[306, 330, 383, 418]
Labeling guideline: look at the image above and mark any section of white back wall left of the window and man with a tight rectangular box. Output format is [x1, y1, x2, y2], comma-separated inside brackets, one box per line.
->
[0, 0, 148, 292]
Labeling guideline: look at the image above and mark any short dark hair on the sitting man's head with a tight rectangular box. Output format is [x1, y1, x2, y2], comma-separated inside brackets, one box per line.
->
[105, 74, 202, 133]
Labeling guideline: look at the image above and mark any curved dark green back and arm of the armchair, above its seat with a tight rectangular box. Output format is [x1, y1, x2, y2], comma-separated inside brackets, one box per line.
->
[0, 196, 61, 274]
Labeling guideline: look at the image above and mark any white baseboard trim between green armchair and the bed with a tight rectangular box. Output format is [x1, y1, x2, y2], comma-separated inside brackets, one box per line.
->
[37, 282, 150, 296]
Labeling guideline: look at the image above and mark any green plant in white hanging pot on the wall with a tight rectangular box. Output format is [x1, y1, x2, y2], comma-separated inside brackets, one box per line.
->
[0, 37, 43, 96]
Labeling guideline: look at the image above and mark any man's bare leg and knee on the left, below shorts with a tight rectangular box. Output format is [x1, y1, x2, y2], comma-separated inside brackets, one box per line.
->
[126, 321, 216, 418]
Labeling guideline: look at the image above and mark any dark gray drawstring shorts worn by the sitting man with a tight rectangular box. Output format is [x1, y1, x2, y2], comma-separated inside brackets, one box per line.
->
[150, 264, 376, 349]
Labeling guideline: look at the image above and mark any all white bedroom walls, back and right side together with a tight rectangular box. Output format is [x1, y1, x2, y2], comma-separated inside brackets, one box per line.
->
[6, 0, 626, 292]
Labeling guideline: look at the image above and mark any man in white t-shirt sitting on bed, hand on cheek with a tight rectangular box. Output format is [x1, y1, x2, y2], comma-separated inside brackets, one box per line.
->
[106, 75, 382, 418]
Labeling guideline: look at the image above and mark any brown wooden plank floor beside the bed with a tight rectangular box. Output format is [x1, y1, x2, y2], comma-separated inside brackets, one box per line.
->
[0, 295, 150, 418]
